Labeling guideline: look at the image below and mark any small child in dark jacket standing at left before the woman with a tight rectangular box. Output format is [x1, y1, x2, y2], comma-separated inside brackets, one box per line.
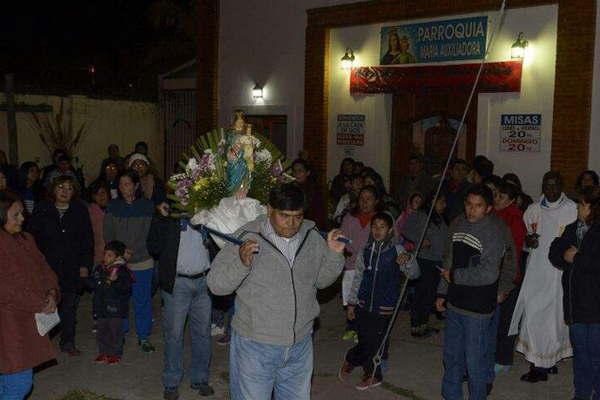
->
[90, 240, 133, 365]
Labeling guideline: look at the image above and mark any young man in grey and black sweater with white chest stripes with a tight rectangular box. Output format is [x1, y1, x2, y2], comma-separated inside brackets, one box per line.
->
[436, 184, 506, 400]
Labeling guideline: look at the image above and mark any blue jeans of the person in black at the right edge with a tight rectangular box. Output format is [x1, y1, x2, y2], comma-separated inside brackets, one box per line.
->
[569, 324, 600, 400]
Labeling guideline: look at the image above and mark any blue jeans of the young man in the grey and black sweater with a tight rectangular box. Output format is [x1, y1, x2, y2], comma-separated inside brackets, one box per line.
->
[442, 310, 491, 400]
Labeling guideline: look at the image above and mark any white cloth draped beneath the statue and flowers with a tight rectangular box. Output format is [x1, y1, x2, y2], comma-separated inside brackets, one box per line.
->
[191, 197, 267, 248]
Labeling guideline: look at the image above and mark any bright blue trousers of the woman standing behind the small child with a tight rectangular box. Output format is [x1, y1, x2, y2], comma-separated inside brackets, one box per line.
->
[123, 268, 154, 340]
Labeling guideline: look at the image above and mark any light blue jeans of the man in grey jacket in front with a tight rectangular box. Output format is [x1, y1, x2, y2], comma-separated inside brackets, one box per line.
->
[229, 328, 313, 400]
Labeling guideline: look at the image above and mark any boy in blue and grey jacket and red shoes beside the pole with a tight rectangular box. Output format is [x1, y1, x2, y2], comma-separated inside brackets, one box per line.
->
[339, 213, 419, 390]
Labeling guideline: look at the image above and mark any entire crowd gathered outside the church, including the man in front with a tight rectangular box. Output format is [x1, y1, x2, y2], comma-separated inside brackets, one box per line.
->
[0, 142, 600, 400]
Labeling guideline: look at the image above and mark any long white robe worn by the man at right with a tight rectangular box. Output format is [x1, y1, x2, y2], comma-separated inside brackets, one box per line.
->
[509, 193, 577, 368]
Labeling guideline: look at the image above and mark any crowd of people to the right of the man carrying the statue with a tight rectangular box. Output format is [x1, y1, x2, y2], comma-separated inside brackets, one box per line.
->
[331, 155, 600, 400]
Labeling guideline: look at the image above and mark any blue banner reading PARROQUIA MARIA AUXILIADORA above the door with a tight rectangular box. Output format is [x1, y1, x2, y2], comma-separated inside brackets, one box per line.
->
[379, 17, 487, 65]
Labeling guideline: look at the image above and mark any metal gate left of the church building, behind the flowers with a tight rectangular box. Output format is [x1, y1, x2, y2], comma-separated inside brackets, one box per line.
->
[160, 90, 198, 179]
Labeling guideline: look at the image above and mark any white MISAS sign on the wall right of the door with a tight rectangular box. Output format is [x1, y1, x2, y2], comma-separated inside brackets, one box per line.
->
[500, 114, 542, 153]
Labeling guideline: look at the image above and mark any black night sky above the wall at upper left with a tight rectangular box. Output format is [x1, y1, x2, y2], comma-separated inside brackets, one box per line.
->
[0, 0, 195, 97]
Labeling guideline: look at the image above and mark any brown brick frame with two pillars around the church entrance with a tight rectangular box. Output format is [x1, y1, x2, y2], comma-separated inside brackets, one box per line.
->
[304, 0, 596, 187]
